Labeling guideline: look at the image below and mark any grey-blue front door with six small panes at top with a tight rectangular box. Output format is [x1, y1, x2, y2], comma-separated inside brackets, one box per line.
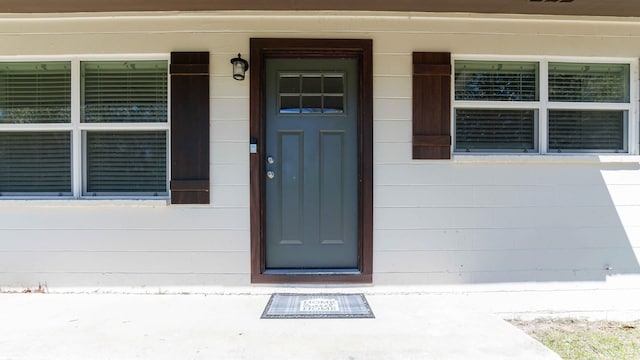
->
[265, 59, 358, 272]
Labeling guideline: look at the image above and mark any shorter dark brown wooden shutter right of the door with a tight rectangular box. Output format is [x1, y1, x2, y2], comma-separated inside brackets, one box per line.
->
[413, 52, 451, 159]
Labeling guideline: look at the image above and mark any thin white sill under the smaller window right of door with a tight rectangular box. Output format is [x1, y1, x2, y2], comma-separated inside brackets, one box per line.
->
[453, 154, 640, 164]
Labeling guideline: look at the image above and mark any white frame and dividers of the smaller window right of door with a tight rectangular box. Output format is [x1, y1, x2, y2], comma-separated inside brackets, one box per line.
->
[451, 54, 639, 156]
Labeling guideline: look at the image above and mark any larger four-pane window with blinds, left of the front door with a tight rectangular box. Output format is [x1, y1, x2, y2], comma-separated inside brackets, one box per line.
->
[0, 59, 169, 198]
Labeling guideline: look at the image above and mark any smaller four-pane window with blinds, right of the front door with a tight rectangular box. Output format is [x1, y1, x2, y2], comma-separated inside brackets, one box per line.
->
[453, 60, 632, 153]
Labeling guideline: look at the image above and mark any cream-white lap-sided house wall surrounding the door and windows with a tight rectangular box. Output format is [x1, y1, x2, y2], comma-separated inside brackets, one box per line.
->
[0, 12, 640, 289]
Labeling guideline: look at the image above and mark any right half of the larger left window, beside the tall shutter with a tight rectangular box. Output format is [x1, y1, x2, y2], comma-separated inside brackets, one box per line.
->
[81, 61, 168, 196]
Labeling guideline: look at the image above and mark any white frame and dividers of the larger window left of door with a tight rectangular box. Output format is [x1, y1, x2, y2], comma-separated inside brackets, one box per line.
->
[0, 53, 171, 201]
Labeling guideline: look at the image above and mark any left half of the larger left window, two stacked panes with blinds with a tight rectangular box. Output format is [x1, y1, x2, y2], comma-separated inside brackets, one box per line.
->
[0, 62, 71, 196]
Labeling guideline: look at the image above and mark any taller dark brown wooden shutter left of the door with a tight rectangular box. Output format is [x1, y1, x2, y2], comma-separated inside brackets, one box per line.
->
[171, 52, 209, 204]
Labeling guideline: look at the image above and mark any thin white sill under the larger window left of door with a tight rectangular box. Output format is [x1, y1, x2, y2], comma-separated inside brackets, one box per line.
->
[0, 198, 169, 207]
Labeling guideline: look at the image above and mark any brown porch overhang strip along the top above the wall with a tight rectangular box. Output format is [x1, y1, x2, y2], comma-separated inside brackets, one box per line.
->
[0, 0, 640, 17]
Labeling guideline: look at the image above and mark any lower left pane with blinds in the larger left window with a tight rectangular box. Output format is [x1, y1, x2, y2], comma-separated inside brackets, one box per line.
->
[0, 132, 71, 195]
